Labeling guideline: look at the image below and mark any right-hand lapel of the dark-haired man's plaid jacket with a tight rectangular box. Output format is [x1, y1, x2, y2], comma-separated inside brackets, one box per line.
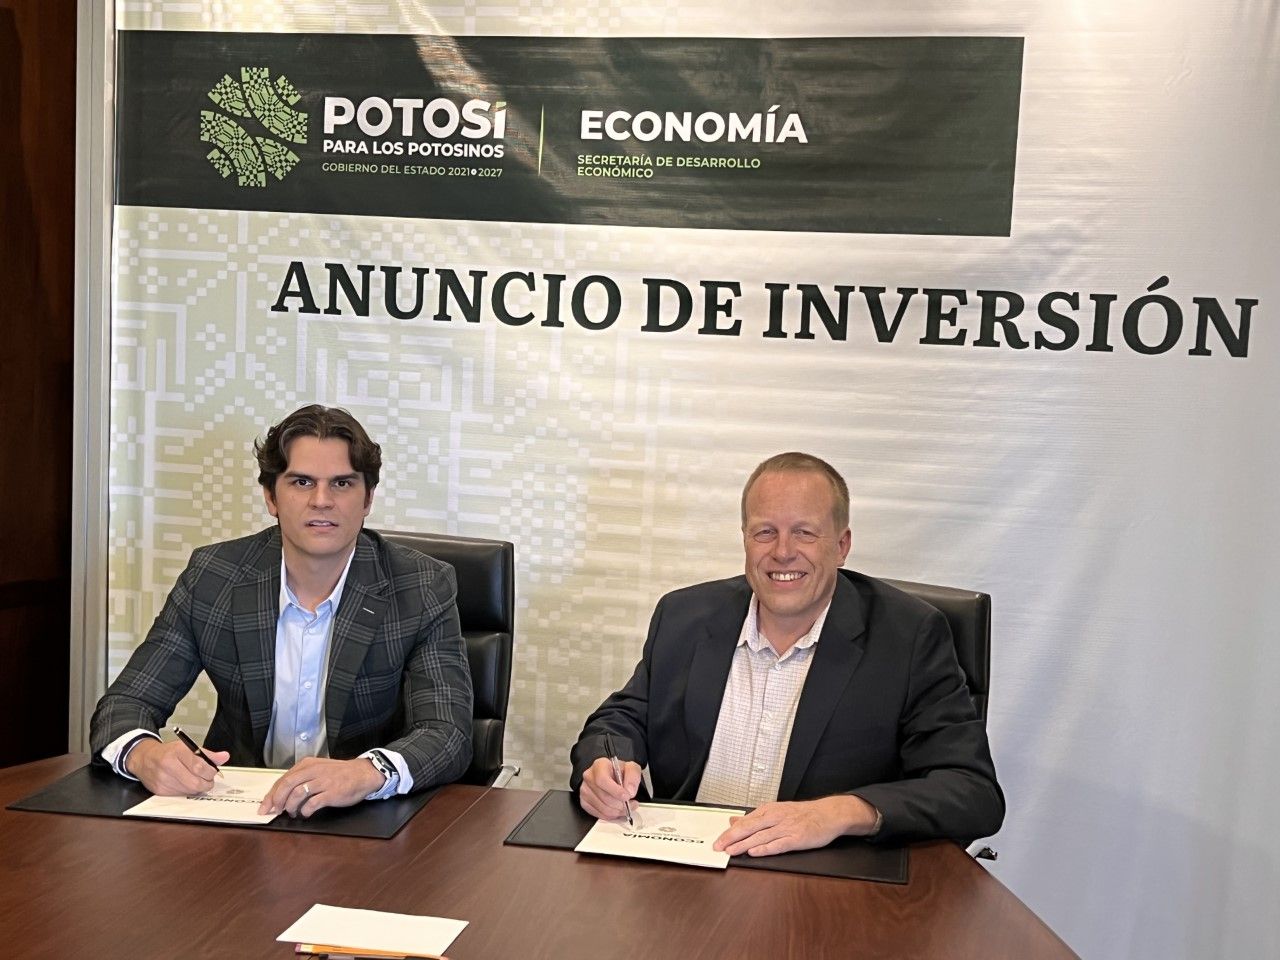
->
[325, 534, 390, 753]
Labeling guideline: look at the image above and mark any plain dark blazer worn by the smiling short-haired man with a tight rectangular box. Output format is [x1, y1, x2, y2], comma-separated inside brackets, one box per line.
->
[571, 570, 1005, 842]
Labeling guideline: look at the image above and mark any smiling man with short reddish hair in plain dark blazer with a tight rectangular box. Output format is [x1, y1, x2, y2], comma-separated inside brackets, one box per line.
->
[571, 453, 1005, 856]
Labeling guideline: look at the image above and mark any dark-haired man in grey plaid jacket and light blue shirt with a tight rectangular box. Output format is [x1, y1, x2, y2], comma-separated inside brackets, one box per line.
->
[90, 404, 471, 817]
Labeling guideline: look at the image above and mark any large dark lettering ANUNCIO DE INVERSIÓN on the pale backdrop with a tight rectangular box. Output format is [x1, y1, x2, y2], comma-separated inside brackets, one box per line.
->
[271, 260, 1258, 357]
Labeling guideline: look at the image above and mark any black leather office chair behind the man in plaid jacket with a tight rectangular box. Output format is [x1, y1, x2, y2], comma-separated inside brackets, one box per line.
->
[383, 532, 520, 786]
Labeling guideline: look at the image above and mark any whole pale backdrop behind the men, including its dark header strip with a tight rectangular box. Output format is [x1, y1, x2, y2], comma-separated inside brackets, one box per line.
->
[106, 0, 1280, 960]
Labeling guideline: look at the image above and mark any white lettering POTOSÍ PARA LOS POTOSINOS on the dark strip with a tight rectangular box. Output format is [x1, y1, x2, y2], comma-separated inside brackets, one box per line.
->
[324, 97, 507, 157]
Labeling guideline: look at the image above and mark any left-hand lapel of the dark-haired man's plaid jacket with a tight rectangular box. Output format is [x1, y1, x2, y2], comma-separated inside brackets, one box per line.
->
[232, 529, 280, 759]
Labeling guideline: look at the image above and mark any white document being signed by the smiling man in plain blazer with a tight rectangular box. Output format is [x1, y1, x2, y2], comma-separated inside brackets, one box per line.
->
[573, 804, 746, 870]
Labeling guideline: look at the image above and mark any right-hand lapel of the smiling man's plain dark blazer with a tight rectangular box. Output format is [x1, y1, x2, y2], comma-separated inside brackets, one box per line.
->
[778, 575, 867, 800]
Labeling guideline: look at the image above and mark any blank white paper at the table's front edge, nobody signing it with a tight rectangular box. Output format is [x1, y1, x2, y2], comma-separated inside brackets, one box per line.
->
[276, 904, 467, 956]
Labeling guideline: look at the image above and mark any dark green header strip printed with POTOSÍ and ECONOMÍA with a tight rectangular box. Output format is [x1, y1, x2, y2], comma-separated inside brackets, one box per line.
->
[118, 31, 1023, 236]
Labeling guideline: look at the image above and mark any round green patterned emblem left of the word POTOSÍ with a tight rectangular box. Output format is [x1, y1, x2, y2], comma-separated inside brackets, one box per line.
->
[200, 67, 307, 187]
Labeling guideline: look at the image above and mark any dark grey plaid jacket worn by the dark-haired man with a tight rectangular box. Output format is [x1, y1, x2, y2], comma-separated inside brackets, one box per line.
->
[90, 527, 471, 790]
